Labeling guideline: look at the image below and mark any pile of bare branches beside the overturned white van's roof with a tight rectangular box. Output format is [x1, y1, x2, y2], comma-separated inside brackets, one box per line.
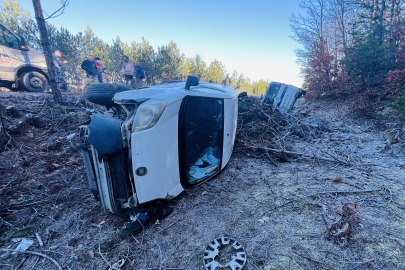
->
[235, 97, 333, 162]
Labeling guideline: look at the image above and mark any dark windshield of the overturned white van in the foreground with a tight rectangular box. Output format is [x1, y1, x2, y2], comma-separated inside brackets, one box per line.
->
[179, 96, 224, 188]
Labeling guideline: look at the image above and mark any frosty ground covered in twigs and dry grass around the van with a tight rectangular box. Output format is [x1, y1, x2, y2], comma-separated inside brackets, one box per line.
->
[0, 89, 405, 270]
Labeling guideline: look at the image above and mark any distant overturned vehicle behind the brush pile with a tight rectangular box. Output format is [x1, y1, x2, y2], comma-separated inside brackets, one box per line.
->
[262, 82, 307, 110]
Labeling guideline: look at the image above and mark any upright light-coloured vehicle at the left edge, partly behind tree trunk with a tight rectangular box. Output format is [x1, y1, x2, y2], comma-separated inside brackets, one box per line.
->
[0, 21, 66, 92]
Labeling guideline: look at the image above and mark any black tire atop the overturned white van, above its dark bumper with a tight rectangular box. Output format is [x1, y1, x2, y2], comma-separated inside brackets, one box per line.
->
[86, 83, 134, 109]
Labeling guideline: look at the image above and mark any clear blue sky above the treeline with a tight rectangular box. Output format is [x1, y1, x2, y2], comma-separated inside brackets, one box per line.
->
[19, 0, 302, 86]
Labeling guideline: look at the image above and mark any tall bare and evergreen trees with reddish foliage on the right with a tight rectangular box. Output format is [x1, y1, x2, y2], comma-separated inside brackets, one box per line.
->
[290, 0, 405, 114]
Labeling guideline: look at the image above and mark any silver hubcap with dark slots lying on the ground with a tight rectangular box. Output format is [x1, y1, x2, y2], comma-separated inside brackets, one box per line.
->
[203, 237, 246, 270]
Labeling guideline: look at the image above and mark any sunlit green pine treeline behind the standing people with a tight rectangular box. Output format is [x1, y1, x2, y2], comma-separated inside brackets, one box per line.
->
[0, 0, 268, 95]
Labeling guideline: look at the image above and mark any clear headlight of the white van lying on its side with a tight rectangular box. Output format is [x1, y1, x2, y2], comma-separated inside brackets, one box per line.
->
[132, 99, 167, 132]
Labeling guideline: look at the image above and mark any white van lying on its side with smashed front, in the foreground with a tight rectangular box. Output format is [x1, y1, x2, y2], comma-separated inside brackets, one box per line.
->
[80, 76, 238, 231]
